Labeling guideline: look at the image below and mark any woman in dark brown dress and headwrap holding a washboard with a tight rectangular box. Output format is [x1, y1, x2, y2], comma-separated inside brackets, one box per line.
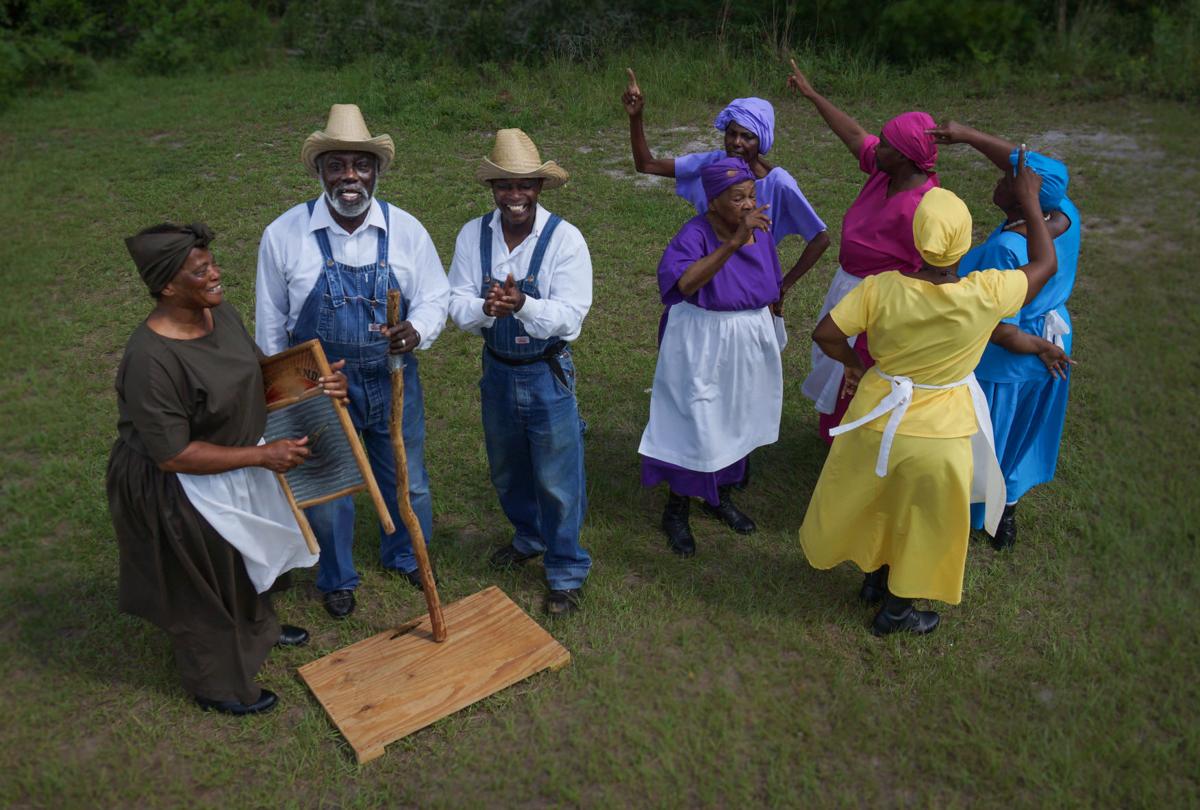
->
[107, 223, 346, 715]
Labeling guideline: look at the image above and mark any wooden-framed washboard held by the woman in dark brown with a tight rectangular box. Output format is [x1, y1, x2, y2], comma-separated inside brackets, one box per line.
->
[263, 340, 396, 553]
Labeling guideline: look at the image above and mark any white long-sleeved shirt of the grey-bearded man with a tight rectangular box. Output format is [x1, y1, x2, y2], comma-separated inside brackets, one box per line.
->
[254, 197, 450, 354]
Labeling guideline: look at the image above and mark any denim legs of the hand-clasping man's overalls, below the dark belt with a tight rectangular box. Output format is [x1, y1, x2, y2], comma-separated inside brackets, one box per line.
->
[479, 350, 592, 590]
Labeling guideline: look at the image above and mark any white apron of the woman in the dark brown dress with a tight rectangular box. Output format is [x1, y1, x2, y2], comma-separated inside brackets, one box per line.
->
[176, 456, 317, 593]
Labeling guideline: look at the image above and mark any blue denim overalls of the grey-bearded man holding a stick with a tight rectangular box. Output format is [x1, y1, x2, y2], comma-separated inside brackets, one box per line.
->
[288, 200, 433, 592]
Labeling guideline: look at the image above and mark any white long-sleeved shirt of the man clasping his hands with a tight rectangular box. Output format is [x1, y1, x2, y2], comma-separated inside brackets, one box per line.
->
[450, 205, 592, 341]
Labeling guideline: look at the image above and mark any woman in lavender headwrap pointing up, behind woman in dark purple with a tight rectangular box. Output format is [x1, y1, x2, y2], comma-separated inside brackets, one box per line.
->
[620, 68, 829, 314]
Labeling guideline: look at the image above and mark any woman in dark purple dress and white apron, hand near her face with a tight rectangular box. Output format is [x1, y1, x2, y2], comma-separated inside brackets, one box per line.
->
[637, 157, 785, 557]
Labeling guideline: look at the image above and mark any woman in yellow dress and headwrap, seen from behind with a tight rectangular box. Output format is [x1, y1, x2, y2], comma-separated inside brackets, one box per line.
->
[800, 150, 1057, 635]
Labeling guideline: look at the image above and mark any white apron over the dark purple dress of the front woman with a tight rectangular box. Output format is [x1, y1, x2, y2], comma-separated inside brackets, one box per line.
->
[637, 302, 784, 473]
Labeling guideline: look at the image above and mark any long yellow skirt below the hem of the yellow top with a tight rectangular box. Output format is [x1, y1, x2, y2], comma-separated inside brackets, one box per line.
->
[800, 427, 973, 605]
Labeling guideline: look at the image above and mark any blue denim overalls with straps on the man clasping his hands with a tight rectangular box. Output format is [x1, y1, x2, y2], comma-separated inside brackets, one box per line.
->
[479, 214, 592, 590]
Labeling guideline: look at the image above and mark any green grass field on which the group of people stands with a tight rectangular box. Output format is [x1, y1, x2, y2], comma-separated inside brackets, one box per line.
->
[0, 52, 1200, 808]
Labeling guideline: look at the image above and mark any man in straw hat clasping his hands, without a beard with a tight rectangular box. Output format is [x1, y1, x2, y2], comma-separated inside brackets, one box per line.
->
[450, 130, 592, 613]
